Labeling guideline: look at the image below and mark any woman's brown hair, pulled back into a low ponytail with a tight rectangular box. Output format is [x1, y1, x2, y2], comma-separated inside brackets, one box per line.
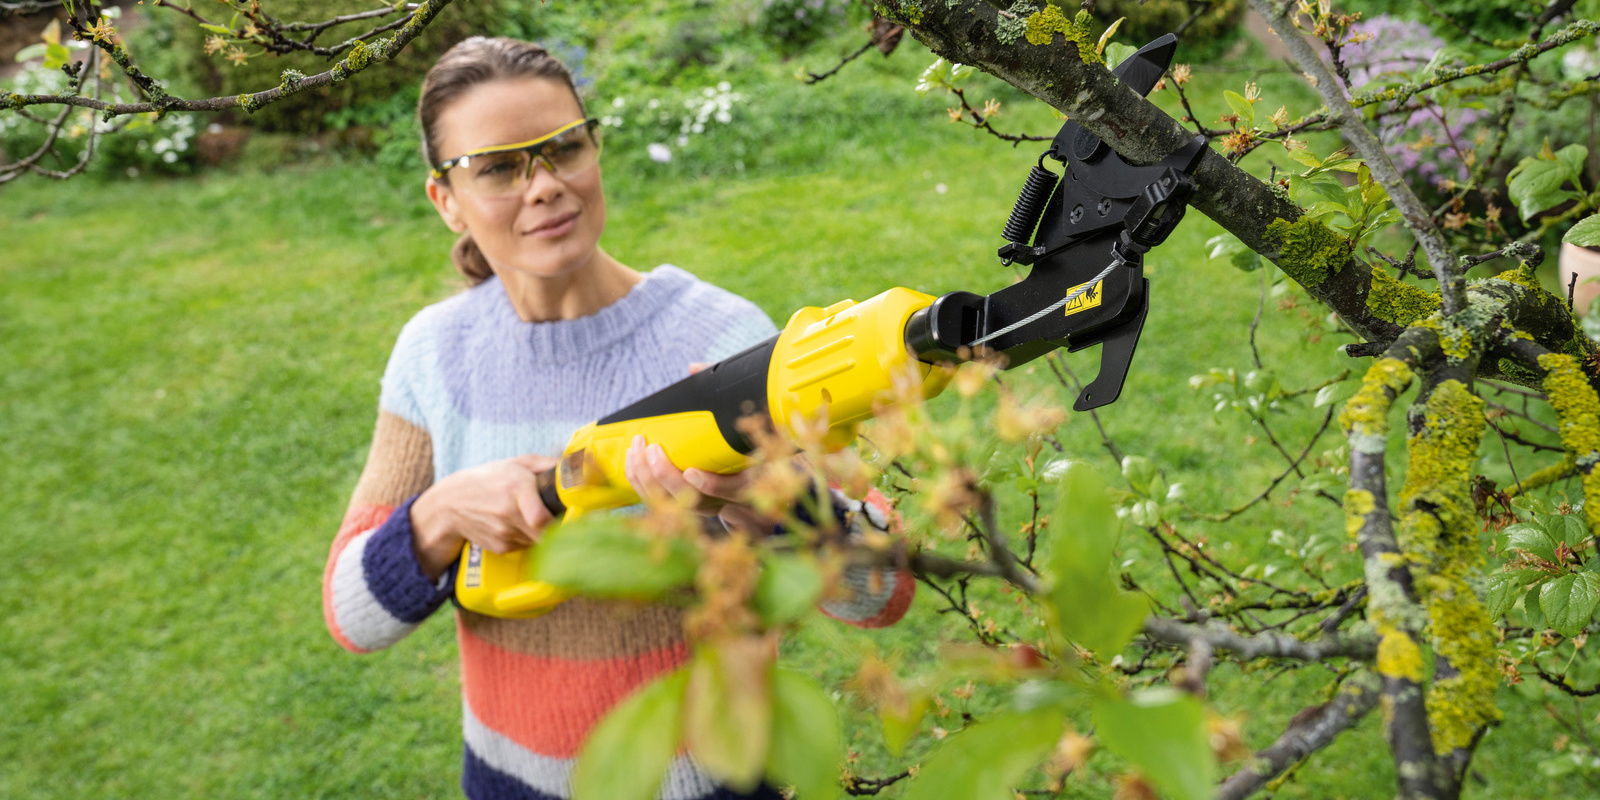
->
[416, 37, 587, 286]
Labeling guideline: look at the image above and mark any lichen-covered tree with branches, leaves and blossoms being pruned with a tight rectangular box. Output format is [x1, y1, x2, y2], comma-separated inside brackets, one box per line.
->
[9, 0, 1600, 798]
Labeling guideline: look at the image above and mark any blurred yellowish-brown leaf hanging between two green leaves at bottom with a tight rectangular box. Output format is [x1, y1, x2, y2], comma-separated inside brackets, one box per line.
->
[683, 638, 773, 792]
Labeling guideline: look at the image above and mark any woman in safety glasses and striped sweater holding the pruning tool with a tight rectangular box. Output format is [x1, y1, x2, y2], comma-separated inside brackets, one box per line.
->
[323, 37, 914, 800]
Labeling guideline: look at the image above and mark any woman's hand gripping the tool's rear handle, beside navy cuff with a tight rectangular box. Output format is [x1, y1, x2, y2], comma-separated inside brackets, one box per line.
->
[411, 456, 555, 578]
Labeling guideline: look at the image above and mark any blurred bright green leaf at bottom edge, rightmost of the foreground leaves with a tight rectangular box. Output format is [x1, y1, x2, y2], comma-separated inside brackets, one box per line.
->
[1093, 686, 1216, 800]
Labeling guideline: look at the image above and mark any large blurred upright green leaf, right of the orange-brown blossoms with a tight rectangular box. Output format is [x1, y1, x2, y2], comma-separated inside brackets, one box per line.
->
[1048, 456, 1155, 659]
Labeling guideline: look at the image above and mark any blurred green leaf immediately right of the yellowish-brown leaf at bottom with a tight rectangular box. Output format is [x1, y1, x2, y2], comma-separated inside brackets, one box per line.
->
[766, 669, 845, 800]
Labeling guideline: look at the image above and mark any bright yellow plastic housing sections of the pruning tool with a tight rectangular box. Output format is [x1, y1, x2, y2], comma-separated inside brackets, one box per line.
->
[456, 288, 949, 618]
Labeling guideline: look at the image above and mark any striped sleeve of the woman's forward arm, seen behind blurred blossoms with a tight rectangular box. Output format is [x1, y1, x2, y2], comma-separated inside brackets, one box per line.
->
[819, 488, 917, 627]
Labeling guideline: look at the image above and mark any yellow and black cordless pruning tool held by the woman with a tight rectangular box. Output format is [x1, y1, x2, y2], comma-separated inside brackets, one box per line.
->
[456, 34, 1205, 618]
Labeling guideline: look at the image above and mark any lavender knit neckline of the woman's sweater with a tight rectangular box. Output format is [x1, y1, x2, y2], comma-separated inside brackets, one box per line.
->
[472, 264, 694, 363]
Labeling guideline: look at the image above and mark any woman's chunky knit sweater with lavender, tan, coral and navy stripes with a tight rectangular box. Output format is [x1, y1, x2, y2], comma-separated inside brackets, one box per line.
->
[323, 266, 915, 800]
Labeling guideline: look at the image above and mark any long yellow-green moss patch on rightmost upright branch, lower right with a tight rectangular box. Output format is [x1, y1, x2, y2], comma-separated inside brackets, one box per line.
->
[1400, 381, 1499, 752]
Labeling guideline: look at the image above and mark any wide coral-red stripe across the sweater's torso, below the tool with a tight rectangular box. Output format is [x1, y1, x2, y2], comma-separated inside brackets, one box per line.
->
[456, 622, 690, 758]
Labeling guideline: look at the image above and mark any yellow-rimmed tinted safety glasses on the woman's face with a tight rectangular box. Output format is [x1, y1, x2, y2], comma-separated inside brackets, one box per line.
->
[434, 118, 600, 197]
